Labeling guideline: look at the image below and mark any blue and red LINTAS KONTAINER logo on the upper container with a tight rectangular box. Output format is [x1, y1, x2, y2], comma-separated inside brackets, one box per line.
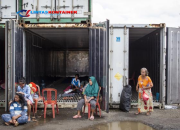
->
[17, 10, 77, 17]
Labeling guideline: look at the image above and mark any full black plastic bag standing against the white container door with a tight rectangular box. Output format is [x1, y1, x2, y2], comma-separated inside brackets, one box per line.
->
[119, 85, 132, 112]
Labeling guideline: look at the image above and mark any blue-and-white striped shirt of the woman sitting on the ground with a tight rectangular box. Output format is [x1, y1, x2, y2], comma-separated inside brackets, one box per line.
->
[10, 102, 27, 117]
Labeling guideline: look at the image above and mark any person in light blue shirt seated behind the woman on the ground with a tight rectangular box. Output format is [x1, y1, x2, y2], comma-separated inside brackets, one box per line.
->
[17, 78, 33, 121]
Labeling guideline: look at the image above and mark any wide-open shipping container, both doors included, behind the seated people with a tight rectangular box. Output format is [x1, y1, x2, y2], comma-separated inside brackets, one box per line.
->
[4, 20, 109, 111]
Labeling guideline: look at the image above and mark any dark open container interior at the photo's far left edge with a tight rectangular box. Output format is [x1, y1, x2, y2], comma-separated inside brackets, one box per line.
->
[0, 28, 5, 101]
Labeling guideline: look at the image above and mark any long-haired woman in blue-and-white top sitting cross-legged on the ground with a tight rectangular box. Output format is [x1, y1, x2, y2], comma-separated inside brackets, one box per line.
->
[2, 93, 28, 126]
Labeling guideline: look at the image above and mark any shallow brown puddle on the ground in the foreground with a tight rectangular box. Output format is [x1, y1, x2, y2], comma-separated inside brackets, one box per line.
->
[80, 121, 155, 130]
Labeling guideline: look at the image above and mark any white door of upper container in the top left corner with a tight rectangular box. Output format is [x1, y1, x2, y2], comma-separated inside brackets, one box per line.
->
[0, 0, 17, 23]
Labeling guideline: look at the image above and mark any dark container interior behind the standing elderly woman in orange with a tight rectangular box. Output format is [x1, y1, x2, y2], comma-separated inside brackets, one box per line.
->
[129, 28, 160, 102]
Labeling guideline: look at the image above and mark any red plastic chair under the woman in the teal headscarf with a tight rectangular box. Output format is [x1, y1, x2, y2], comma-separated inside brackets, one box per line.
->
[83, 86, 101, 119]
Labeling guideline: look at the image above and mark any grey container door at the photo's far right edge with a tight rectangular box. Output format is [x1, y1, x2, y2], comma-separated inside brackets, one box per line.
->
[167, 28, 180, 104]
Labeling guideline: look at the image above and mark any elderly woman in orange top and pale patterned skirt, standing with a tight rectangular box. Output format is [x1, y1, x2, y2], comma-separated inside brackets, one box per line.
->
[135, 68, 153, 115]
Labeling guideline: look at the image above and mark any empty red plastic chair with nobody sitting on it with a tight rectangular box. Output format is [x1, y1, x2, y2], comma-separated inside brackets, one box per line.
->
[42, 88, 59, 118]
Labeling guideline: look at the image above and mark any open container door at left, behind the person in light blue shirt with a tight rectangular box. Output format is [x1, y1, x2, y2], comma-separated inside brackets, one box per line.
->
[5, 20, 23, 111]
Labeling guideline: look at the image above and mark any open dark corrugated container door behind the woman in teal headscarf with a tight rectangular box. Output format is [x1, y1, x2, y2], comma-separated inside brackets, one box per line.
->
[89, 20, 109, 112]
